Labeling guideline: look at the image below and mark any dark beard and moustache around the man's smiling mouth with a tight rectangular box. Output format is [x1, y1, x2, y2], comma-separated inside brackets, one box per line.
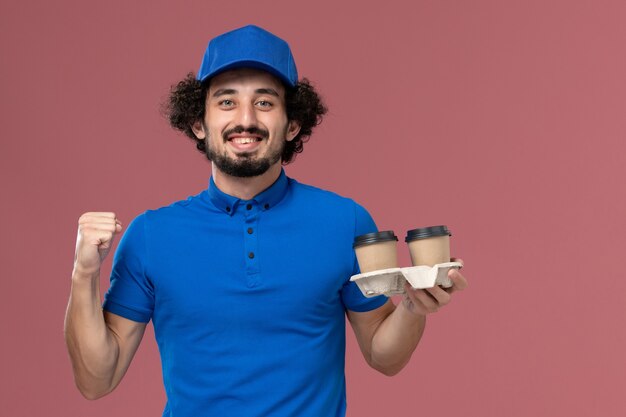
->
[205, 122, 285, 178]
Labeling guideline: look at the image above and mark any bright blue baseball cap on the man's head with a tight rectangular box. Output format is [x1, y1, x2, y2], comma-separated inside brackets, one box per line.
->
[197, 25, 298, 87]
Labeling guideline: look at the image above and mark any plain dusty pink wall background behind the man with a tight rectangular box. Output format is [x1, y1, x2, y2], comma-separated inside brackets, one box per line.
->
[0, 0, 626, 417]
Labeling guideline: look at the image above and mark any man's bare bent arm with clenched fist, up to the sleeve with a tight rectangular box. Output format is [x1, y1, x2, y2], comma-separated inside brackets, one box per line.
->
[65, 212, 146, 399]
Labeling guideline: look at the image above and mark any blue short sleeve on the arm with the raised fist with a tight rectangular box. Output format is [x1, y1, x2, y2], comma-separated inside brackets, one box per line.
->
[103, 213, 154, 323]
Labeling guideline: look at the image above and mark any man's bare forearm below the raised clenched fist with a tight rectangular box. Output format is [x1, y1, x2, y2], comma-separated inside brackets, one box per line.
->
[65, 271, 119, 399]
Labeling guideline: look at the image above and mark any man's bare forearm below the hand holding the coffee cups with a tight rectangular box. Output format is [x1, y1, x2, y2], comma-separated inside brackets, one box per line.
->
[371, 302, 426, 376]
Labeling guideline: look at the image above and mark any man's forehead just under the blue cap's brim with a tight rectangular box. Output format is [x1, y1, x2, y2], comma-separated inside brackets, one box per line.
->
[209, 68, 285, 97]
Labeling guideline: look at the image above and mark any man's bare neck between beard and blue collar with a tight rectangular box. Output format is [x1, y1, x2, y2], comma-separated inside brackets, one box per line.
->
[212, 162, 281, 200]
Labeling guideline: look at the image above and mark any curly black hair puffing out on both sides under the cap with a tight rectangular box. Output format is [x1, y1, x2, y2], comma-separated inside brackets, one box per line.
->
[162, 72, 328, 165]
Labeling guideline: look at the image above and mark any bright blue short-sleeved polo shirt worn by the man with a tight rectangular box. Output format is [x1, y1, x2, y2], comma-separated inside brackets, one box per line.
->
[104, 171, 386, 417]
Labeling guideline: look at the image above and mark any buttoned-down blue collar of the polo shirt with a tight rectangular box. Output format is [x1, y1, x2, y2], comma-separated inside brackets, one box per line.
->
[208, 169, 289, 216]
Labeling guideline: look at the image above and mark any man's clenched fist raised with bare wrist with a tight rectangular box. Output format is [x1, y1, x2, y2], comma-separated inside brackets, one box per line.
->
[74, 212, 122, 274]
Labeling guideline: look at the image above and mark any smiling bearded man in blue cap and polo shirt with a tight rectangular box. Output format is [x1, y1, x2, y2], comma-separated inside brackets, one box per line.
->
[65, 26, 466, 417]
